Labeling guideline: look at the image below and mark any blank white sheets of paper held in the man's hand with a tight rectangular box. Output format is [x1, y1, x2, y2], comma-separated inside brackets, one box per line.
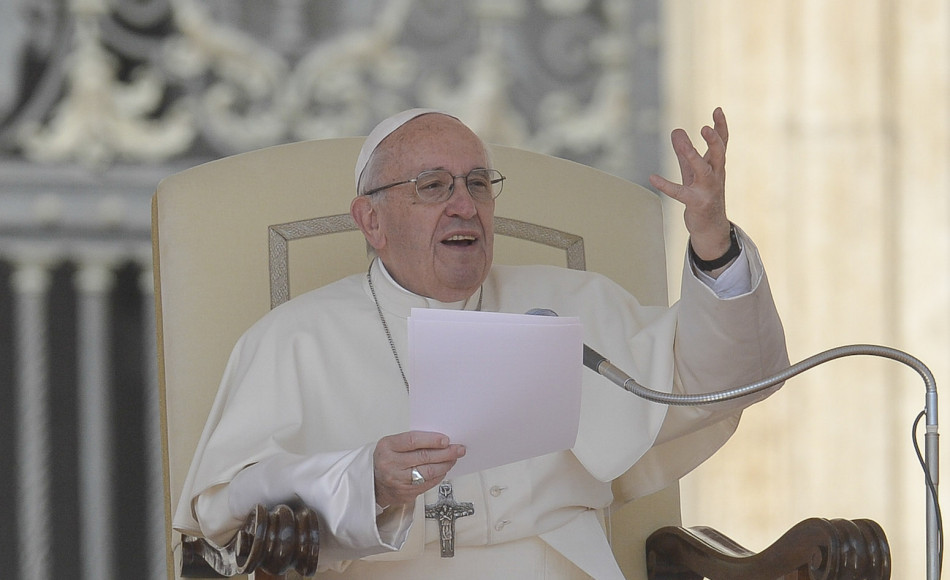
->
[408, 309, 583, 477]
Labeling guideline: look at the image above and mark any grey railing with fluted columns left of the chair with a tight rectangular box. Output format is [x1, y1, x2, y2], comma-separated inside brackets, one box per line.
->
[0, 167, 164, 580]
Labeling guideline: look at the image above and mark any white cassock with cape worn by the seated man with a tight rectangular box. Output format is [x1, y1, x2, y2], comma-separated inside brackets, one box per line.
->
[174, 231, 788, 579]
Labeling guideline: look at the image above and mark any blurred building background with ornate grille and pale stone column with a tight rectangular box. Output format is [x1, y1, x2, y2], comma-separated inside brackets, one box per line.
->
[0, 0, 950, 579]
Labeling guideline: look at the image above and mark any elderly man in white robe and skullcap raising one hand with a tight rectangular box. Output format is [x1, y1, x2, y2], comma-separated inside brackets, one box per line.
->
[174, 109, 788, 580]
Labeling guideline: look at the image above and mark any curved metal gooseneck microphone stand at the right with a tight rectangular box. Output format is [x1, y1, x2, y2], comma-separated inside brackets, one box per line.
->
[584, 344, 943, 580]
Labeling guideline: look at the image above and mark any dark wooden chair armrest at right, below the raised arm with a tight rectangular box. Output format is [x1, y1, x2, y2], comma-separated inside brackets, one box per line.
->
[646, 518, 891, 580]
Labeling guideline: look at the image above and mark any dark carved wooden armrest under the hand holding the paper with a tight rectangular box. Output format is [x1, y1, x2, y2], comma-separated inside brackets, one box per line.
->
[181, 505, 320, 578]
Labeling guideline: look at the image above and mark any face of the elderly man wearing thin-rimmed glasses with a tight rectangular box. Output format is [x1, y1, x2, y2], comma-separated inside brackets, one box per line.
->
[364, 114, 495, 302]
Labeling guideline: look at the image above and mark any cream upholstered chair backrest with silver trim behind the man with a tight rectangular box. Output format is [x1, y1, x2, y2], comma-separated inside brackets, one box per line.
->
[152, 138, 679, 578]
